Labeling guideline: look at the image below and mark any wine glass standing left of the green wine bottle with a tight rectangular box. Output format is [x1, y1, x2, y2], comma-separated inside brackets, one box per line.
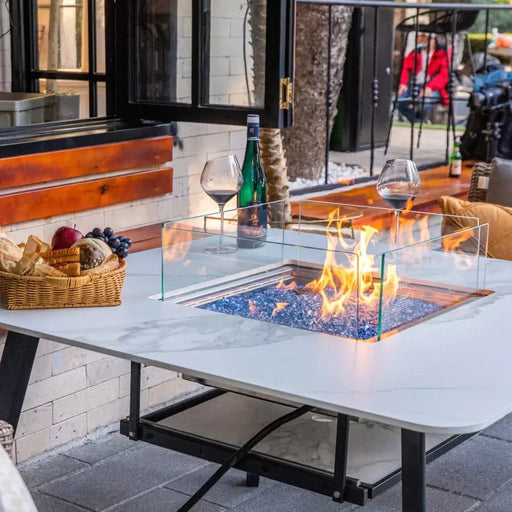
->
[201, 155, 243, 254]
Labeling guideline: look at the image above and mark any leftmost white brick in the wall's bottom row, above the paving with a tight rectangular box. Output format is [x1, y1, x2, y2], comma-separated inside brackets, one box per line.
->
[16, 414, 87, 464]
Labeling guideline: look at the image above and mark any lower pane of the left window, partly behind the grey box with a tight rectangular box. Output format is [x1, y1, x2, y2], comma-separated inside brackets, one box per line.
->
[39, 79, 89, 121]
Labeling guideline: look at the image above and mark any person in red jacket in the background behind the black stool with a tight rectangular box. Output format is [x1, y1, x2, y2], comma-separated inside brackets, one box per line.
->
[398, 34, 449, 123]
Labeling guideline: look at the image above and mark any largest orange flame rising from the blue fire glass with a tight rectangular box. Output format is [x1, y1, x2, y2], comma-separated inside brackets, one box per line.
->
[304, 210, 400, 317]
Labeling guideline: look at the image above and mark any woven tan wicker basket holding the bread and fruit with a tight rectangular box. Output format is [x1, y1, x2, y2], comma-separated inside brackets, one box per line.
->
[0, 260, 126, 309]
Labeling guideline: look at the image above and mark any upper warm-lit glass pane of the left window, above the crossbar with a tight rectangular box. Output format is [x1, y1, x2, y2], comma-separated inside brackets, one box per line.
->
[37, 0, 89, 71]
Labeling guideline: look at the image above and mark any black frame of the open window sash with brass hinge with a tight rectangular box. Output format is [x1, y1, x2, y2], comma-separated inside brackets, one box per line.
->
[111, 0, 295, 128]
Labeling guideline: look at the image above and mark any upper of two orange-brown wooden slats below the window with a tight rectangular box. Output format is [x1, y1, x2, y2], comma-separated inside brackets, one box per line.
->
[0, 169, 172, 225]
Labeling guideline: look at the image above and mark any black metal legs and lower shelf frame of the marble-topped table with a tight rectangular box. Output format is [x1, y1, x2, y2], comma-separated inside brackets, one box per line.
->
[0, 331, 473, 512]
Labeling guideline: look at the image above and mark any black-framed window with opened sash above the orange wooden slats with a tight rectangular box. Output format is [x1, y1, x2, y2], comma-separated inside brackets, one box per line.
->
[12, 0, 295, 127]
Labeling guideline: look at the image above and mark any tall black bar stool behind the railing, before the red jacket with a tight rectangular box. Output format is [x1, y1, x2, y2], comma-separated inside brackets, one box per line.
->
[384, 9, 479, 159]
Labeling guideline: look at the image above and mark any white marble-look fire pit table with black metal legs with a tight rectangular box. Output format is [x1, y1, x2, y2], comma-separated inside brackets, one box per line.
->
[0, 240, 512, 512]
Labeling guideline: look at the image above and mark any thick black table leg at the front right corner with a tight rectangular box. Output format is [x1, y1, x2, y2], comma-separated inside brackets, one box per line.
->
[402, 429, 427, 512]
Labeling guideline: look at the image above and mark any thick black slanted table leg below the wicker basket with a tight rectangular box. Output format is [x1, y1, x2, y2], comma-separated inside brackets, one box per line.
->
[0, 331, 39, 431]
